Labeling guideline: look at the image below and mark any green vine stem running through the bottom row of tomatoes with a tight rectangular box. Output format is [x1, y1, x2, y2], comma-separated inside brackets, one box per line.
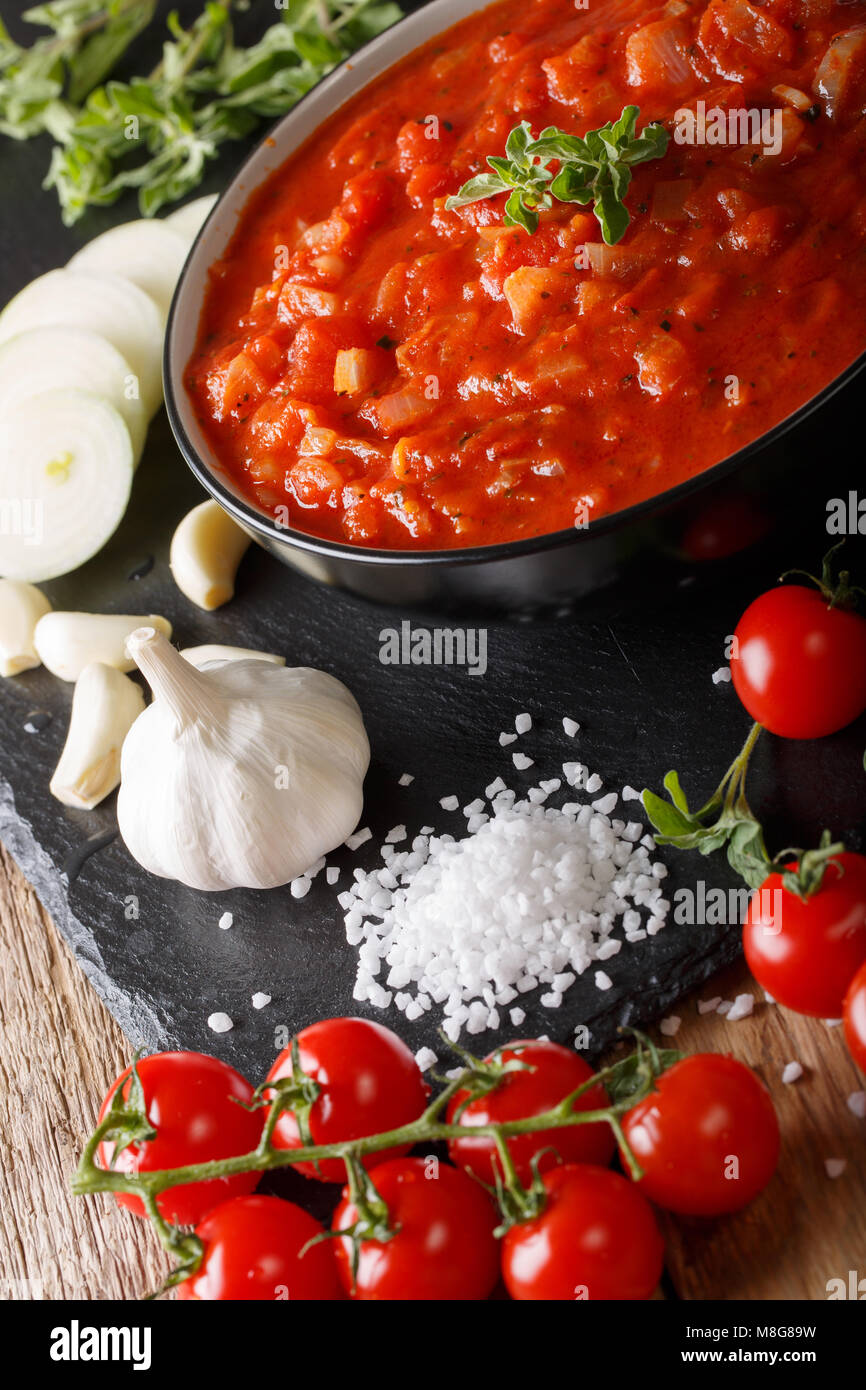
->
[71, 1030, 680, 1289]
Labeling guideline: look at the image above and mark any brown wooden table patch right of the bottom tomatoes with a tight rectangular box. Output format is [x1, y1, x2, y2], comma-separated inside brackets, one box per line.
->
[663, 965, 866, 1300]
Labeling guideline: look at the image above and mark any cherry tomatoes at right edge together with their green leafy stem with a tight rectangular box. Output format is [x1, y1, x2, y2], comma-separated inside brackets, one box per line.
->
[644, 542, 866, 1058]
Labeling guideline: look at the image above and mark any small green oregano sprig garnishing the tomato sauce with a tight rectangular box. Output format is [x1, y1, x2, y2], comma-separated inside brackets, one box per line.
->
[445, 106, 670, 246]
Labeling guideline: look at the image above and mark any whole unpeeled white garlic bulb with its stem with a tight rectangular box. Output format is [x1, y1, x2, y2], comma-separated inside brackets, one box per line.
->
[117, 627, 370, 892]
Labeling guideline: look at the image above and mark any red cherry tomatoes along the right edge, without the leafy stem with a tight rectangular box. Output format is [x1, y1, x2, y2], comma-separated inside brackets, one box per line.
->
[731, 552, 866, 1070]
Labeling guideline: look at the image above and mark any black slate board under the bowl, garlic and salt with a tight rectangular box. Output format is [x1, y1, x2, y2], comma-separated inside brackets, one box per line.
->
[0, 6, 866, 1080]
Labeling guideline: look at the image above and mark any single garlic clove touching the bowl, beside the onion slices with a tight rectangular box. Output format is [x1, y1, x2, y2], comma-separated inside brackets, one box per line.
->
[170, 502, 250, 612]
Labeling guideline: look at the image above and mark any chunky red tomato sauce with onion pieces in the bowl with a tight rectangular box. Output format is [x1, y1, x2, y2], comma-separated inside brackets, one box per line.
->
[186, 0, 866, 549]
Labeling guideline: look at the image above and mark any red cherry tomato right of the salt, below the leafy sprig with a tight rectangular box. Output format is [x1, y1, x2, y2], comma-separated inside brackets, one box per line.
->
[742, 852, 866, 1019]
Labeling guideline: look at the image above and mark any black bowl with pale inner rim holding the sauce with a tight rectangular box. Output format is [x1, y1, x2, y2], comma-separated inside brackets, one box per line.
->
[164, 0, 866, 612]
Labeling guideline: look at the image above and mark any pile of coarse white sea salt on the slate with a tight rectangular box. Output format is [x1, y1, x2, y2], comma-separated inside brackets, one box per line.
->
[338, 763, 670, 1041]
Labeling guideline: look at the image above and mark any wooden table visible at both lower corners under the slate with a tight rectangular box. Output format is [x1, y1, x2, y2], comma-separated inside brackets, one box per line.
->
[0, 849, 866, 1300]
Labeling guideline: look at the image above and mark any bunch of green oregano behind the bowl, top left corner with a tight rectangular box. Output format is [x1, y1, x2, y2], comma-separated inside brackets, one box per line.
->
[0, 0, 402, 225]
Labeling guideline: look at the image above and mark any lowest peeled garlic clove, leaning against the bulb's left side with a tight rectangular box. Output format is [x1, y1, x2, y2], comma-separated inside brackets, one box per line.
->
[50, 662, 145, 810]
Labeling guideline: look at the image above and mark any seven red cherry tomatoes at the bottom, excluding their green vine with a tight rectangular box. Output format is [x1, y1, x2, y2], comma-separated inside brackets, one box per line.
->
[100, 1019, 778, 1301]
